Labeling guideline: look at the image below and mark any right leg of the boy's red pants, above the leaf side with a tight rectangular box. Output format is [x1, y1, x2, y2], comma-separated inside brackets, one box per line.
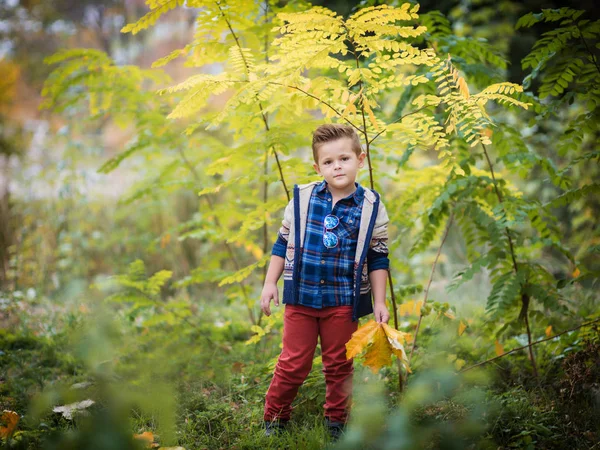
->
[319, 306, 358, 423]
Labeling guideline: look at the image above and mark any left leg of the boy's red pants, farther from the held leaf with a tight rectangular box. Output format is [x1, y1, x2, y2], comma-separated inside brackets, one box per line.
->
[264, 305, 318, 421]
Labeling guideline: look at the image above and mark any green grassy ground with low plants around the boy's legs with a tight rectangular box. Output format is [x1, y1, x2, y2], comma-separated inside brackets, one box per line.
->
[0, 294, 600, 450]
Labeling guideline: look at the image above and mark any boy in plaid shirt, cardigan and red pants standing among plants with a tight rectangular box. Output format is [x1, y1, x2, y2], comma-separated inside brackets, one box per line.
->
[260, 124, 390, 438]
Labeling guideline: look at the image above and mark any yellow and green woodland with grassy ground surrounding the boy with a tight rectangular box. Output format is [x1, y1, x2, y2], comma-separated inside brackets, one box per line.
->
[0, 0, 600, 450]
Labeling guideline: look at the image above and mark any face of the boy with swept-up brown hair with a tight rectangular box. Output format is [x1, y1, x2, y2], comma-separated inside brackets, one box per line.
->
[313, 138, 366, 191]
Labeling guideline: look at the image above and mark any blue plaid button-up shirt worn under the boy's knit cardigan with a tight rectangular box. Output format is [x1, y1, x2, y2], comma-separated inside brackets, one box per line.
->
[272, 181, 389, 308]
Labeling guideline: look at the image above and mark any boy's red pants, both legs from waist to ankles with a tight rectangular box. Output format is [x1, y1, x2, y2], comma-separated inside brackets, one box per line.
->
[264, 305, 358, 423]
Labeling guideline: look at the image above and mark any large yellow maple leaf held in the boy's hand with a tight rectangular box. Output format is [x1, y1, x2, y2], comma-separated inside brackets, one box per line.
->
[346, 320, 412, 373]
